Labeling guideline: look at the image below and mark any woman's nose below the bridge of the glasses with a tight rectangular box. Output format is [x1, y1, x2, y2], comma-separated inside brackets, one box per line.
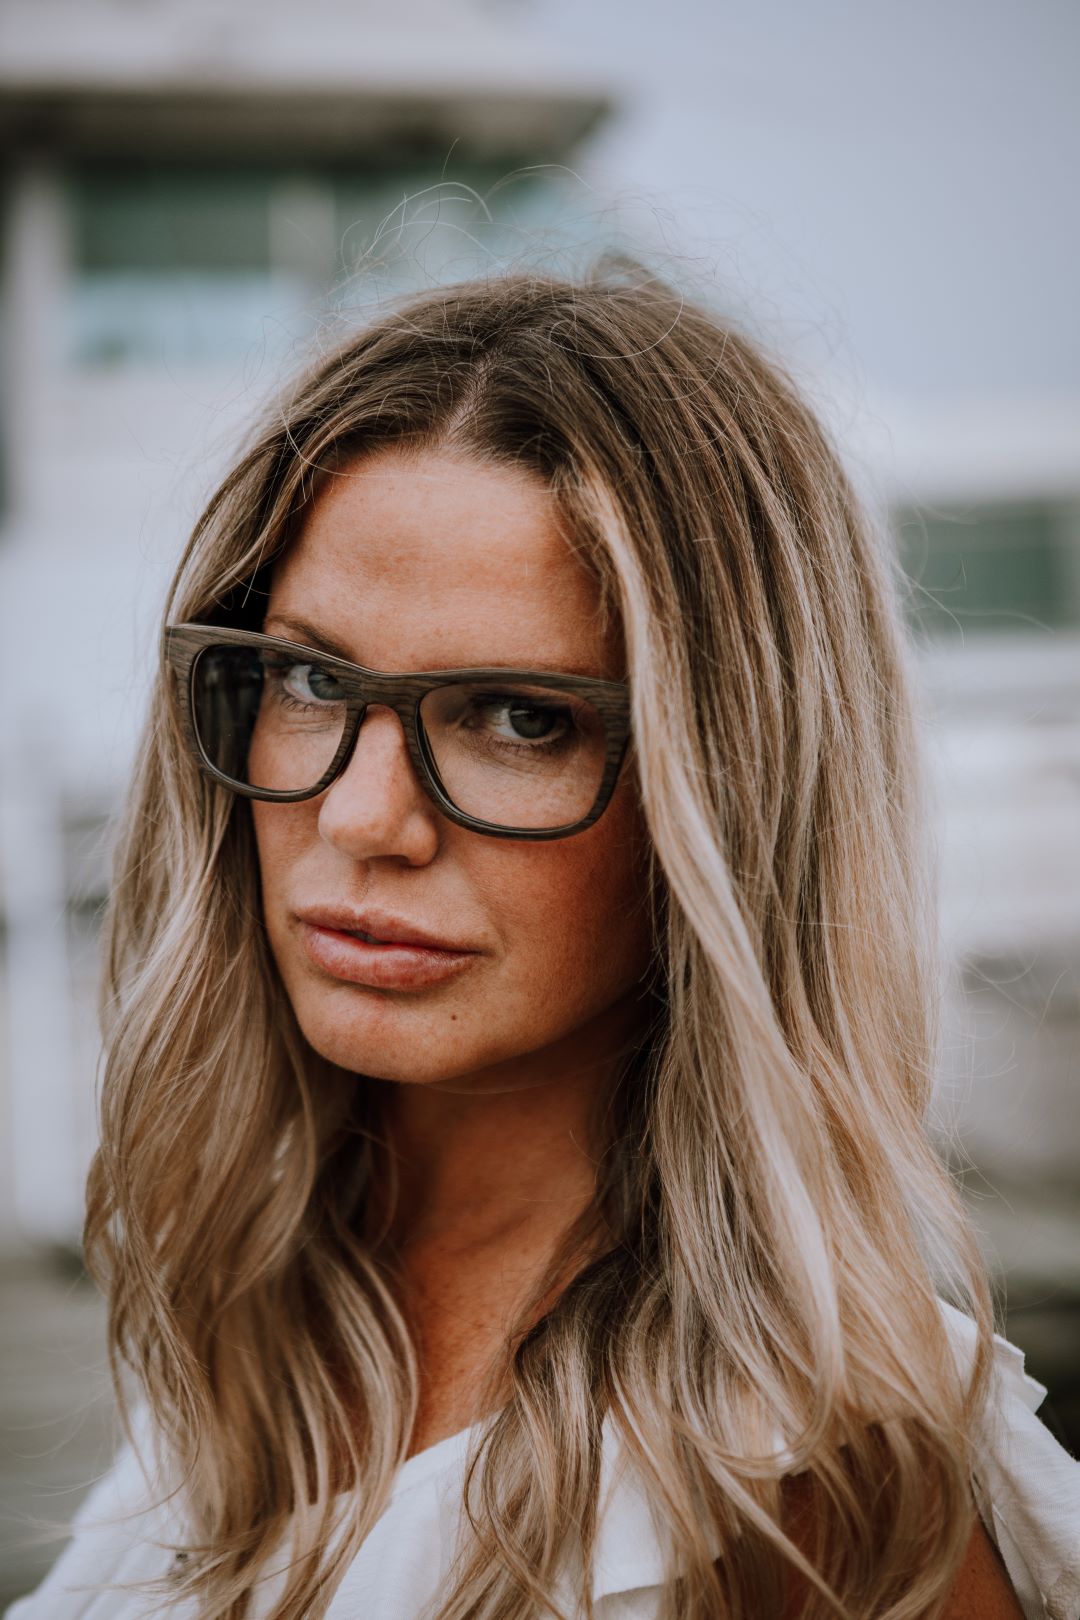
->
[319, 703, 440, 867]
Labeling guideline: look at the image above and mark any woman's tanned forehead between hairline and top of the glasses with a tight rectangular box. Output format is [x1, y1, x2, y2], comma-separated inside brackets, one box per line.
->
[266, 450, 623, 679]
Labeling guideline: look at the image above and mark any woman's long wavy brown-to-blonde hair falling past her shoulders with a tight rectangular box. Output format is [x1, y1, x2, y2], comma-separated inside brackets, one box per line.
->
[86, 262, 993, 1620]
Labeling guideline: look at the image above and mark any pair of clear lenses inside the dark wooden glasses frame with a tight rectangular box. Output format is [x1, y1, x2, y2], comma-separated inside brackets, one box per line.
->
[193, 646, 606, 831]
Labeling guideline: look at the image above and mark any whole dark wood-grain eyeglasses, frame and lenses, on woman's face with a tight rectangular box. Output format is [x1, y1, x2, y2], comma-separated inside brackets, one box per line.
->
[164, 624, 630, 839]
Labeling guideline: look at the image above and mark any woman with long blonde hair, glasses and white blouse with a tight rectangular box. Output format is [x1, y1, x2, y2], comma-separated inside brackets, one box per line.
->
[13, 269, 1080, 1620]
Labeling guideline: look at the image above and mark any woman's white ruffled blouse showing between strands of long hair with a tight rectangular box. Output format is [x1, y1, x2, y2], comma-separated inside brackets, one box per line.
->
[6, 1306, 1080, 1620]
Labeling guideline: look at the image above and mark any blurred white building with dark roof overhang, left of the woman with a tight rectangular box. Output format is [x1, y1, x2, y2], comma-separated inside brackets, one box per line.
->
[0, 0, 606, 1246]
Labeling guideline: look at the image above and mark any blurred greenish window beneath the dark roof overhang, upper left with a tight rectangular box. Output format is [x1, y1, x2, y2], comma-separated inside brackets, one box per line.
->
[70, 154, 560, 368]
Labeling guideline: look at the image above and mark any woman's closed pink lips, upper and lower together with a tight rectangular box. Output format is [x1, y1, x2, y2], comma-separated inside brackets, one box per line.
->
[296, 906, 479, 990]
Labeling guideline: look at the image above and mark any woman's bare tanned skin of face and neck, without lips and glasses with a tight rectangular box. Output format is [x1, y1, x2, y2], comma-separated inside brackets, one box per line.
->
[251, 450, 651, 1452]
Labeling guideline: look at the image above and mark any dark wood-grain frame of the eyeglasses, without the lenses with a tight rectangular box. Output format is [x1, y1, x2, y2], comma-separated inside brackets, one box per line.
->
[164, 624, 630, 839]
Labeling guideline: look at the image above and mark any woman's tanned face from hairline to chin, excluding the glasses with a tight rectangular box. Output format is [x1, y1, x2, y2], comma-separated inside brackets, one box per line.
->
[251, 450, 649, 1089]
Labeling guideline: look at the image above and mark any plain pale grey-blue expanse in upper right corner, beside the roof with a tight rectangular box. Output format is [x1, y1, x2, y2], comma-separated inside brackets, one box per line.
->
[528, 0, 1080, 400]
